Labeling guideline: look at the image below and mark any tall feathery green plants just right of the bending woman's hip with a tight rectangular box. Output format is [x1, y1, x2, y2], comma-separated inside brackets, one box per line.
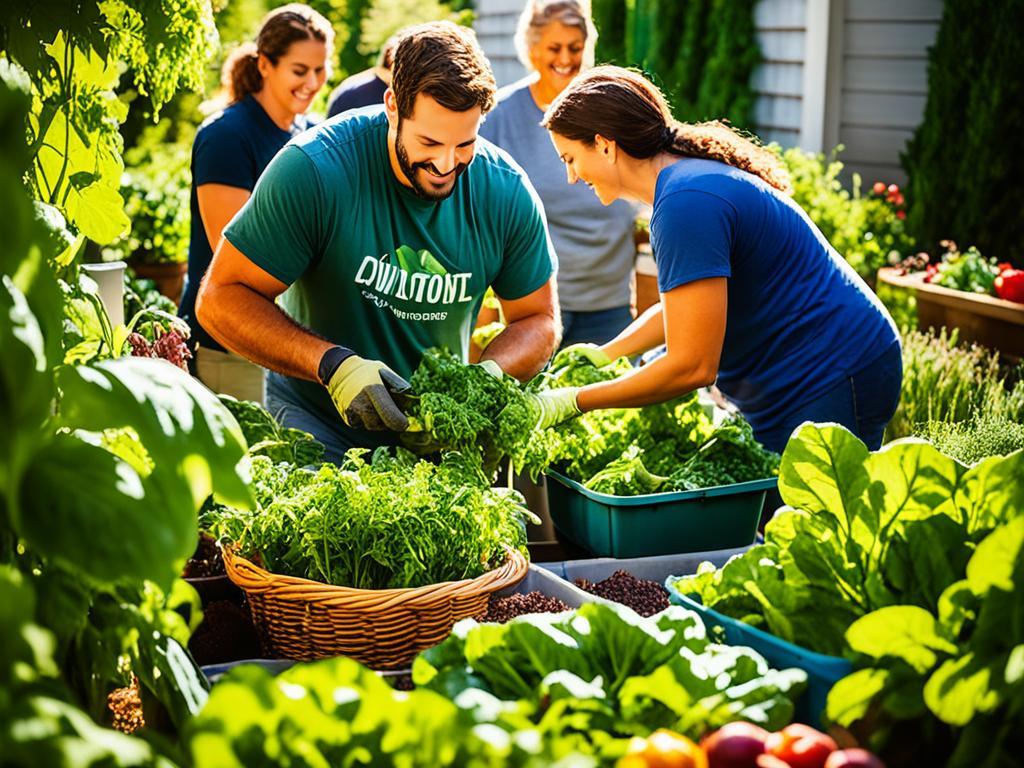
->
[886, 329, 1024, 440]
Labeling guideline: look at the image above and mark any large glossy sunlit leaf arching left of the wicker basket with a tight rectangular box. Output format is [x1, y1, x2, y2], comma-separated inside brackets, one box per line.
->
[57, 357, 252, 515]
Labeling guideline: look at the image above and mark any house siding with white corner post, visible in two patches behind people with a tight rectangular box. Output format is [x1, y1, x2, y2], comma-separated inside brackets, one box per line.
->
[475, 0, 942, 183]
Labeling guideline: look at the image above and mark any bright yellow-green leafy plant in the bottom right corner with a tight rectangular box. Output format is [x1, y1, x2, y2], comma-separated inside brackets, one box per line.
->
[827, 517, 1024, 768]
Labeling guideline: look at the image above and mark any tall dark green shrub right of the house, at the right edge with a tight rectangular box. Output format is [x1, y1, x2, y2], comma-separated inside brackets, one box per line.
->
[901, 0, 1024, 266]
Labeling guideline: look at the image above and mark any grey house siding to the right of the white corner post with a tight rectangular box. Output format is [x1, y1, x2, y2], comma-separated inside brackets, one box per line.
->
[827, 0, 942, 184]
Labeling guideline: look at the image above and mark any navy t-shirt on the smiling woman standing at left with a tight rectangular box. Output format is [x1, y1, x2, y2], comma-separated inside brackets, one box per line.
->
[178, 94, 310, 351]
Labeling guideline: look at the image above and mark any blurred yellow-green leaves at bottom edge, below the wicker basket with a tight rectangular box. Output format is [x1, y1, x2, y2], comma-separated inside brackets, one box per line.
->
[186, 658, 573, 768]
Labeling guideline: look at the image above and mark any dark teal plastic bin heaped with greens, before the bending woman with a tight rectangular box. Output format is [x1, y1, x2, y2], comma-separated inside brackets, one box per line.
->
[547, 470, 778, 557]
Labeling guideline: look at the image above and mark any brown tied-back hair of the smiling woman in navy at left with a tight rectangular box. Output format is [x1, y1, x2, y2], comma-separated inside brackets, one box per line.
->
[220, 3, 334, 103]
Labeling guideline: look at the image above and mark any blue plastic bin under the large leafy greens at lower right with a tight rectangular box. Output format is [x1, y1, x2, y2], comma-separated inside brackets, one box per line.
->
[665, 577, 853, 728]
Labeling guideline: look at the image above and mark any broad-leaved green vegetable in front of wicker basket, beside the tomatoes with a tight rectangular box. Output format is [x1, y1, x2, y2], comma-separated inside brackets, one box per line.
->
[413, 603, 805, 754]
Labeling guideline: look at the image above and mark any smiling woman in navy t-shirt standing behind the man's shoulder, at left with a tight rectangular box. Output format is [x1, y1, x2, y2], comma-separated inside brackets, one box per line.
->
[180, 3, 334, 402]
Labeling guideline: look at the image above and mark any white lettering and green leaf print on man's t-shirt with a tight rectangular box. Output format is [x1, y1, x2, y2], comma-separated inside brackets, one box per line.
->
[354, 245, 473, 322]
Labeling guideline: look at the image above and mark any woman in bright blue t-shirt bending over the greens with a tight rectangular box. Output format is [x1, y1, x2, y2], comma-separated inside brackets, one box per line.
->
[537, 67, 902, 451]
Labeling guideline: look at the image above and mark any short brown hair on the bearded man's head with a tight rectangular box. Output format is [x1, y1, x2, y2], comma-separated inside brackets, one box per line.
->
[391, 22, 498, 118]
